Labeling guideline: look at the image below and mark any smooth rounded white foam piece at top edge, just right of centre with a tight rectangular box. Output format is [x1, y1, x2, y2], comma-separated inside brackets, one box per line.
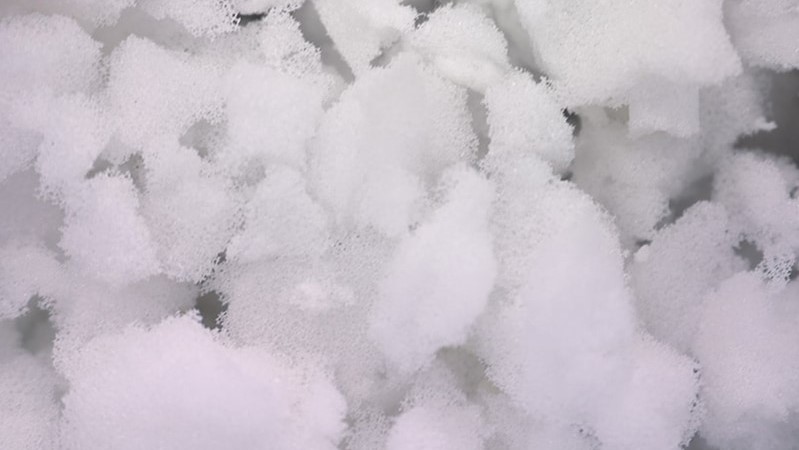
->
[405, 4, 510, 92]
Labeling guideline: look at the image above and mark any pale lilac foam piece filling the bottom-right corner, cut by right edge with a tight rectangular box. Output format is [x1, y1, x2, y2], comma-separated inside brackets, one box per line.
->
[695, 273, 799, 450]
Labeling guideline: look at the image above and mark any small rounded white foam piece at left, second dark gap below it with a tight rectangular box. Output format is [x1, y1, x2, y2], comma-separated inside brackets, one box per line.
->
[59, 174, 160, 284]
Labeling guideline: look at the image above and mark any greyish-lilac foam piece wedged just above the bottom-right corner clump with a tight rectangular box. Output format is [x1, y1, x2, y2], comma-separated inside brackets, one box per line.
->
[630, 202, 743, 352]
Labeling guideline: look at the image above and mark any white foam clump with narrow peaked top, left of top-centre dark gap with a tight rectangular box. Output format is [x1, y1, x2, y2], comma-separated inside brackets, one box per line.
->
[212, 9, 336, 173]
